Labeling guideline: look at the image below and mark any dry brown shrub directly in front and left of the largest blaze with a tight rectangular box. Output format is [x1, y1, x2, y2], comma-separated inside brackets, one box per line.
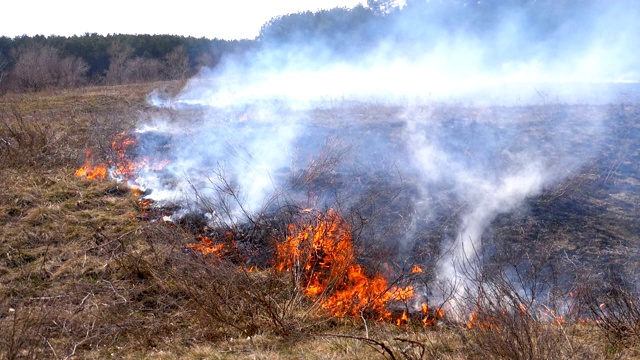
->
[164, 243, 320, 337]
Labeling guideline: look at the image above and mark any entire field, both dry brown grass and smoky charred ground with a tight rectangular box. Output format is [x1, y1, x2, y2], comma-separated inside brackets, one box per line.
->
[0, 82, 640, 359]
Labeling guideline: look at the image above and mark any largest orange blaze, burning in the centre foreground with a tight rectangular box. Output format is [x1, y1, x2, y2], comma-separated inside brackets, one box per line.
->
[276, 210, 414, 321]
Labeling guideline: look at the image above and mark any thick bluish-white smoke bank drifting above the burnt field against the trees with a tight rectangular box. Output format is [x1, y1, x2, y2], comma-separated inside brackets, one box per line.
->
[158, 1, 640, 107]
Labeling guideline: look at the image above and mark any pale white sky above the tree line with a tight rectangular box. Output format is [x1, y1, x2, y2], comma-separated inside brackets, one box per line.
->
[0, 0, 366, 40]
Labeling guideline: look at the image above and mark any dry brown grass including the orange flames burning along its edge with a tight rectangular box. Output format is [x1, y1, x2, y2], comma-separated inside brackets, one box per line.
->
[0, 85, 640, 359]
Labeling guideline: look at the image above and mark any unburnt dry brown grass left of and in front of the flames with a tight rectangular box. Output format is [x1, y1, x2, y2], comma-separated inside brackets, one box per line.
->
[0, 83, 640, 359]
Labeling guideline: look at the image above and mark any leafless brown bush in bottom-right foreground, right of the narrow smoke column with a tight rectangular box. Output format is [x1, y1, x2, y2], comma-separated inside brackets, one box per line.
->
[463, 255, 595, 359]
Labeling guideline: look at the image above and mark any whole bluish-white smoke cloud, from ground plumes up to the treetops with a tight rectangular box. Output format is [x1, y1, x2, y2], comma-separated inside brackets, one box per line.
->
[138, 1, 640, 300]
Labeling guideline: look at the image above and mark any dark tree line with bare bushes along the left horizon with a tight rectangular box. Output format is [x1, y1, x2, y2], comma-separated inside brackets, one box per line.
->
[0, 33, 254, 93]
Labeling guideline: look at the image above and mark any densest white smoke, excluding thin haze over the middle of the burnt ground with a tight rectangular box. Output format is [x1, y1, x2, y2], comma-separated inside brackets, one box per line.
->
[139, 1, 640, 304]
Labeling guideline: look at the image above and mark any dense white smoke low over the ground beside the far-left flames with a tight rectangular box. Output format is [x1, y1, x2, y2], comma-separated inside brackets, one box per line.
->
[135, 105, 299, 220]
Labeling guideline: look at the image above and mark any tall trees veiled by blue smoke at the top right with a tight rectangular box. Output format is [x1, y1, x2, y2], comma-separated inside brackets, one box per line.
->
[258, 0, 608, 57]
